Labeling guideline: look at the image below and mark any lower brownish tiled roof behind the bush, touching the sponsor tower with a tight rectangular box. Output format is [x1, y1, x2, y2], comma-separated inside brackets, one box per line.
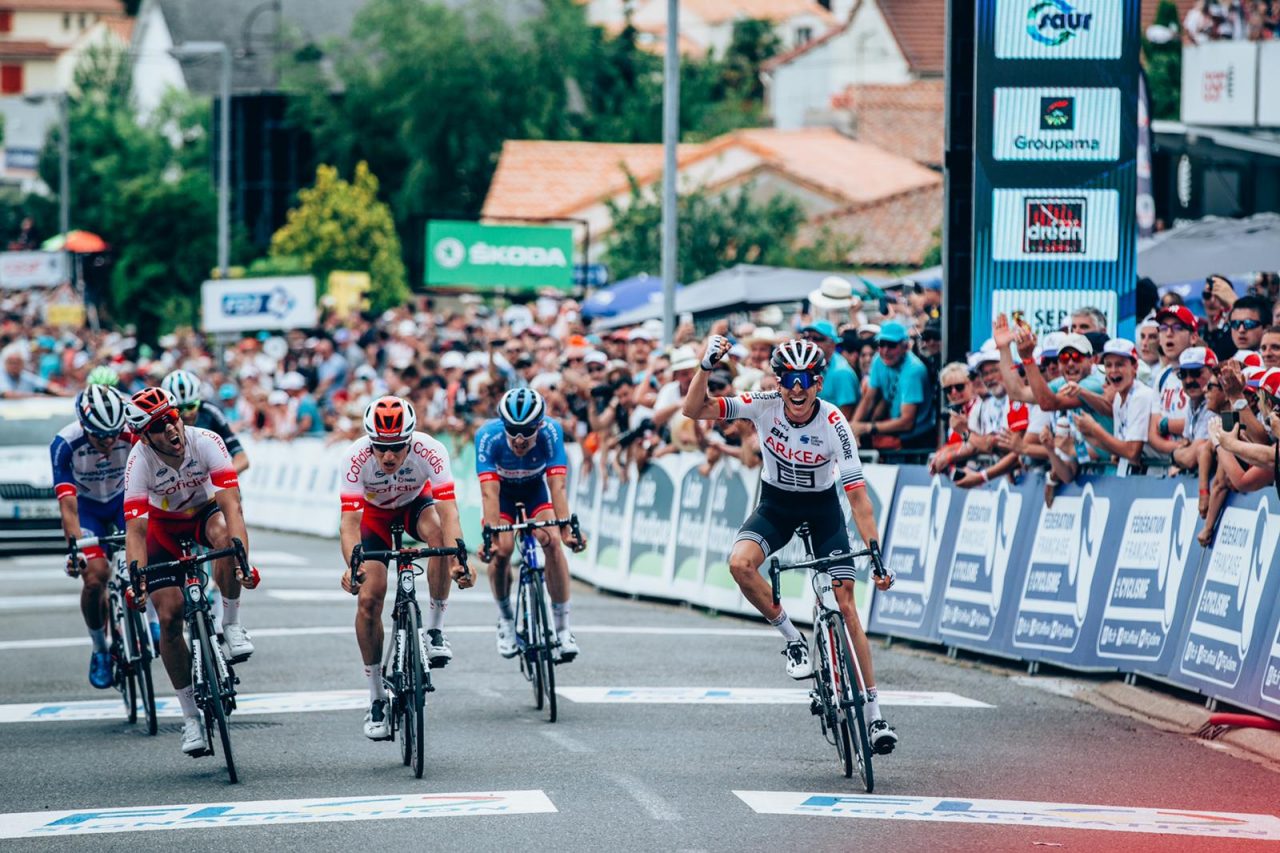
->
[797, 182, 942, 266]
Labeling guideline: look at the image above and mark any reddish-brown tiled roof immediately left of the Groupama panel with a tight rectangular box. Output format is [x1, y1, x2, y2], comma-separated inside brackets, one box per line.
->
[831, 78, 946, 168]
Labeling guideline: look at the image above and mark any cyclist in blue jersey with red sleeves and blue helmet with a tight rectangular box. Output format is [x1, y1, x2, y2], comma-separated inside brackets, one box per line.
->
[476, 388, 586, 663]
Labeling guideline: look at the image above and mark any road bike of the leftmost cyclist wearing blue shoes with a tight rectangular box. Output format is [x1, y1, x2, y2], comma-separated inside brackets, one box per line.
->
[70, 533, 157, 735]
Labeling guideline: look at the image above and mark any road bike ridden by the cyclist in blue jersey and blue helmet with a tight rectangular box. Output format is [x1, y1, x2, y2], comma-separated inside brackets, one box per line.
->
[481, 503, 582, 722]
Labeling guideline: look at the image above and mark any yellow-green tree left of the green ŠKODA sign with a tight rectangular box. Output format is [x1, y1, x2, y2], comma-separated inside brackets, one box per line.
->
[271, 161, 408, 311]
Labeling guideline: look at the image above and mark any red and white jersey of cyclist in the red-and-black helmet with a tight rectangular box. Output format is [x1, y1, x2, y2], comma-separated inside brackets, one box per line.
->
[124, 427, 239, 519]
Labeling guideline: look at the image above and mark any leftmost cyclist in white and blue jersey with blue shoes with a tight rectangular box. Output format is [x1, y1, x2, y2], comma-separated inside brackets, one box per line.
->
[49, 386, 133, 689]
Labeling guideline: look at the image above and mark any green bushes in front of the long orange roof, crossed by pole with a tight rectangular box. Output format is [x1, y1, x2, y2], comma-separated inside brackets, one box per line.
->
[604, 175, 854, 282]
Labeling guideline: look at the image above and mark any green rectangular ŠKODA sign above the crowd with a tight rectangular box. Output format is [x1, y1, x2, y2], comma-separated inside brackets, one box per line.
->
[426, 219, 573, 289]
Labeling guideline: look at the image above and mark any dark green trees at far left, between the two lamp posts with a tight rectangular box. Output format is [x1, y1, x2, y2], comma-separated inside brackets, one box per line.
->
[38, 49, 218, 339]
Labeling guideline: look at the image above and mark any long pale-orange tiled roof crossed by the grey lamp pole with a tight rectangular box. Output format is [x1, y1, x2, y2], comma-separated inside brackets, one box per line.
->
[483, 128, 942, 218]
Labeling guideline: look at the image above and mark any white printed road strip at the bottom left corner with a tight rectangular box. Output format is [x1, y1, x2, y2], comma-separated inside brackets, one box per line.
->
[0, 790, 557, 838]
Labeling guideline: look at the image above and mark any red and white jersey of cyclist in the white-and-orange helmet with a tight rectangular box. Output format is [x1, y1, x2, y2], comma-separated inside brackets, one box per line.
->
[342, 433, 453, 512]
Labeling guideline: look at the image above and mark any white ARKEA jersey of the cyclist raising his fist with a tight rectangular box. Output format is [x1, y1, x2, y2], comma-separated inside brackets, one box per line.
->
[717, 391, 867, 492]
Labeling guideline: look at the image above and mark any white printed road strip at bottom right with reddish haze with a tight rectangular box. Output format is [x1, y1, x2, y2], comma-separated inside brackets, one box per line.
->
[733, 790, 1280, 841]
